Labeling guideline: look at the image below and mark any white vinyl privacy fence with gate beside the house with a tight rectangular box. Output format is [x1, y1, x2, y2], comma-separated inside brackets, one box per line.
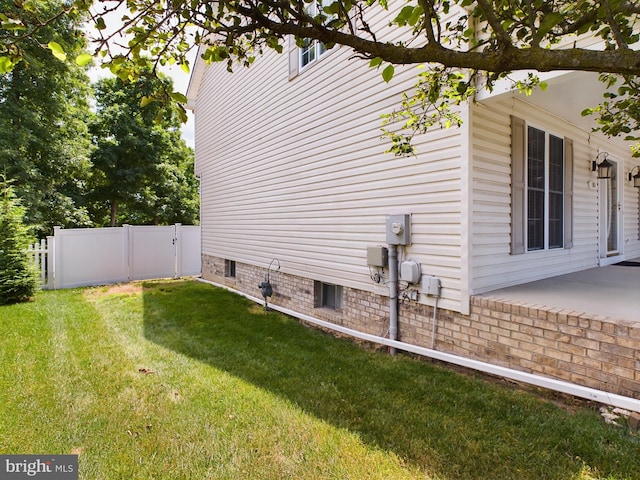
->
[29, 224, 200, 289]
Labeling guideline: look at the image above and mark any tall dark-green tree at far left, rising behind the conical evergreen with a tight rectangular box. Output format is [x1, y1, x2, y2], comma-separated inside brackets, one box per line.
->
[0, 0, 91, 236]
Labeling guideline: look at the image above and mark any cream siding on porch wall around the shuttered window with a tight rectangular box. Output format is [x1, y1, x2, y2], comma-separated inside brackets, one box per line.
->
[471, 96, 640, 293]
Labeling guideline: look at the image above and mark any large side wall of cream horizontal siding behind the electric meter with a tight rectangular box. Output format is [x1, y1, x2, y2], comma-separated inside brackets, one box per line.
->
[195, 17, 462, 310]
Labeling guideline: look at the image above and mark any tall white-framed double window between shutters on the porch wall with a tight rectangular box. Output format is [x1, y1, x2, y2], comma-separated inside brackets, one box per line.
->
[526, 127, 565, 251]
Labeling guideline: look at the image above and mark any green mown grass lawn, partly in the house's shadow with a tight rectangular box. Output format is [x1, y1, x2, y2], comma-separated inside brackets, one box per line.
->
[0, 281, 640, 480]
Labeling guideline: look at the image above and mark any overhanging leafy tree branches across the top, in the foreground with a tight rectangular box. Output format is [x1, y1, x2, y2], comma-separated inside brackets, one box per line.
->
[0, 0, 640, 153]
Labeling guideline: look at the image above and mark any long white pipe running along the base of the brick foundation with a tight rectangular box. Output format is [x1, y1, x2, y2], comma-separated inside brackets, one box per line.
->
[198, 279, 640, 412]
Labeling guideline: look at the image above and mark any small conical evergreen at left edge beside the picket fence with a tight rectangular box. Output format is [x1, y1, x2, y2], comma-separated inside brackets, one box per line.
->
[0, 181, 37, 305]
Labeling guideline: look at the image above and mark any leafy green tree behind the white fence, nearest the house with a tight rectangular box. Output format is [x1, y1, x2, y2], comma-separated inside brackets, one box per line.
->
[88, 71, 198, 226]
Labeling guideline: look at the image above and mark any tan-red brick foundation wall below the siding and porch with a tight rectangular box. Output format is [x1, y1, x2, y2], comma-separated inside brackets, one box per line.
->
[202, 255, 640, 398]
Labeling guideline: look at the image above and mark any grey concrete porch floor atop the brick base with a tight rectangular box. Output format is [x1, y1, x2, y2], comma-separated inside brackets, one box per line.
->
[480, 259, 640, 322]
